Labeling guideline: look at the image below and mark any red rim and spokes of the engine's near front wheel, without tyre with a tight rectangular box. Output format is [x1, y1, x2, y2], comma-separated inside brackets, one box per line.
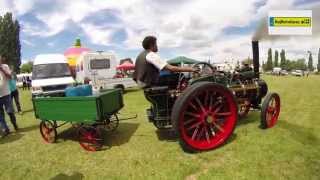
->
[266, 96, 280, 128]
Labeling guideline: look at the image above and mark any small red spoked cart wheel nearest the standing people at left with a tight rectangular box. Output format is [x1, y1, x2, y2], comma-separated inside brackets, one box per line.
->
[39, 121, 57, 143]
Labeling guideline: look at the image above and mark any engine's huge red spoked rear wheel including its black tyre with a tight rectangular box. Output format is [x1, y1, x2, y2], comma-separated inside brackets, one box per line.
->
[172, 82, 238, 152]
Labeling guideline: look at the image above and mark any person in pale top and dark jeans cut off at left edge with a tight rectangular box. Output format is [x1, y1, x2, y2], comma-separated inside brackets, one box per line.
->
[0, 56, 18, 136]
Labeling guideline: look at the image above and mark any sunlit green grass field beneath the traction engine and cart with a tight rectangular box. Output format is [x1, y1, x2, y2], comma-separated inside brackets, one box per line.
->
[0, 76, 320, 180]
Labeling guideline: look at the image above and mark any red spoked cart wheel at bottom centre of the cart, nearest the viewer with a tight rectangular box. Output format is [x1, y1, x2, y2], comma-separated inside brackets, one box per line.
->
[78, 126, 103, 151]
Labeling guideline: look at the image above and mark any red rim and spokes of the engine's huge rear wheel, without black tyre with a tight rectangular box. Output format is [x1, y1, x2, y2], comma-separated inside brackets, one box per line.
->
[179, 88, 237, 150]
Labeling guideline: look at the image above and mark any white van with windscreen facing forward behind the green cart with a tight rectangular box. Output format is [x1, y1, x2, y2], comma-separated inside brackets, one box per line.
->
[31, 54, 75, 96]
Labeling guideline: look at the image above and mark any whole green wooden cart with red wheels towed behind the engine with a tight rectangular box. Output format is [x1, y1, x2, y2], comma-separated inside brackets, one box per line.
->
[32, 89, 124, 151]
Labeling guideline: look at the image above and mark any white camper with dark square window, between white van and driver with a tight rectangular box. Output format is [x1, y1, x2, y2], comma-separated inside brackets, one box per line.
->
[76, 51, 137, 90]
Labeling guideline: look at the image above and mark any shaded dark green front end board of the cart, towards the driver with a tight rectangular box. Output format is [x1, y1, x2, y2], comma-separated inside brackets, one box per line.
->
[97, 89, 123, 118]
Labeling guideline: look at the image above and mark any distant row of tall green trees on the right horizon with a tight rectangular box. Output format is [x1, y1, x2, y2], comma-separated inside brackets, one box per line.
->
[262, 48, 320, 71]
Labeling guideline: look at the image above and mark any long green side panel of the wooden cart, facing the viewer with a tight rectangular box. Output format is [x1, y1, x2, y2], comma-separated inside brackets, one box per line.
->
[34, 97, 98, 123]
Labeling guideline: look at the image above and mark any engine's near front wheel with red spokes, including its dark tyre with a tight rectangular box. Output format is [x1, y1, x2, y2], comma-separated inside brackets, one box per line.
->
[261, 93, 280, 129]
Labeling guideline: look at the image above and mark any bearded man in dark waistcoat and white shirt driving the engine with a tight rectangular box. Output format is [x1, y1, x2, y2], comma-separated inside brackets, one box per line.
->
[133, 36, 197, 88]
